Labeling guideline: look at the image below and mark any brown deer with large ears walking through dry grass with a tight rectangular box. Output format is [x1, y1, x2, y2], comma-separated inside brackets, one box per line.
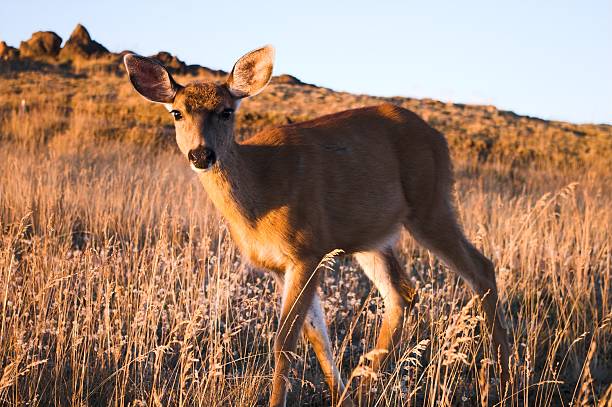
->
[124, 45, 510, 406]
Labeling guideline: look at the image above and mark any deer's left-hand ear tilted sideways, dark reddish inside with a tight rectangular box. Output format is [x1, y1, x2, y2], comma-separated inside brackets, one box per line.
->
[123, 54, 180, 103]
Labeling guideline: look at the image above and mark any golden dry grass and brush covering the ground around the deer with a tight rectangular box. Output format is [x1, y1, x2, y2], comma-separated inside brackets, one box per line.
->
[0, 65, 612, 406]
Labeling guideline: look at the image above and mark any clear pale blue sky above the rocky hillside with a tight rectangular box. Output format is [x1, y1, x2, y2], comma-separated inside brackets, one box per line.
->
[0, 0, 612, 123]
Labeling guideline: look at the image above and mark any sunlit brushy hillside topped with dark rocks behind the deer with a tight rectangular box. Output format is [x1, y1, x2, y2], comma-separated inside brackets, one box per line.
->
[0, 25, 612, 169]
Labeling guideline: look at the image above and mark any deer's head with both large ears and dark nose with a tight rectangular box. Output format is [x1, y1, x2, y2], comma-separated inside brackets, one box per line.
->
[124, 46, 274, 172]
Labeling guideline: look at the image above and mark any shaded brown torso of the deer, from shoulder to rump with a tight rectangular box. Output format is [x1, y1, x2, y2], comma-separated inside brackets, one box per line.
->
[241, 104, 450, 264]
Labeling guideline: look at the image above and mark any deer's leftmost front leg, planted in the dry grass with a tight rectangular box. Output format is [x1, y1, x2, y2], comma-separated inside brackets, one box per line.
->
[270, 259, 319, 407]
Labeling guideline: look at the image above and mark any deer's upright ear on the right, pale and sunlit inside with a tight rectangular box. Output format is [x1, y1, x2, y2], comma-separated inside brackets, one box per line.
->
[227, 45, 274, 98]
